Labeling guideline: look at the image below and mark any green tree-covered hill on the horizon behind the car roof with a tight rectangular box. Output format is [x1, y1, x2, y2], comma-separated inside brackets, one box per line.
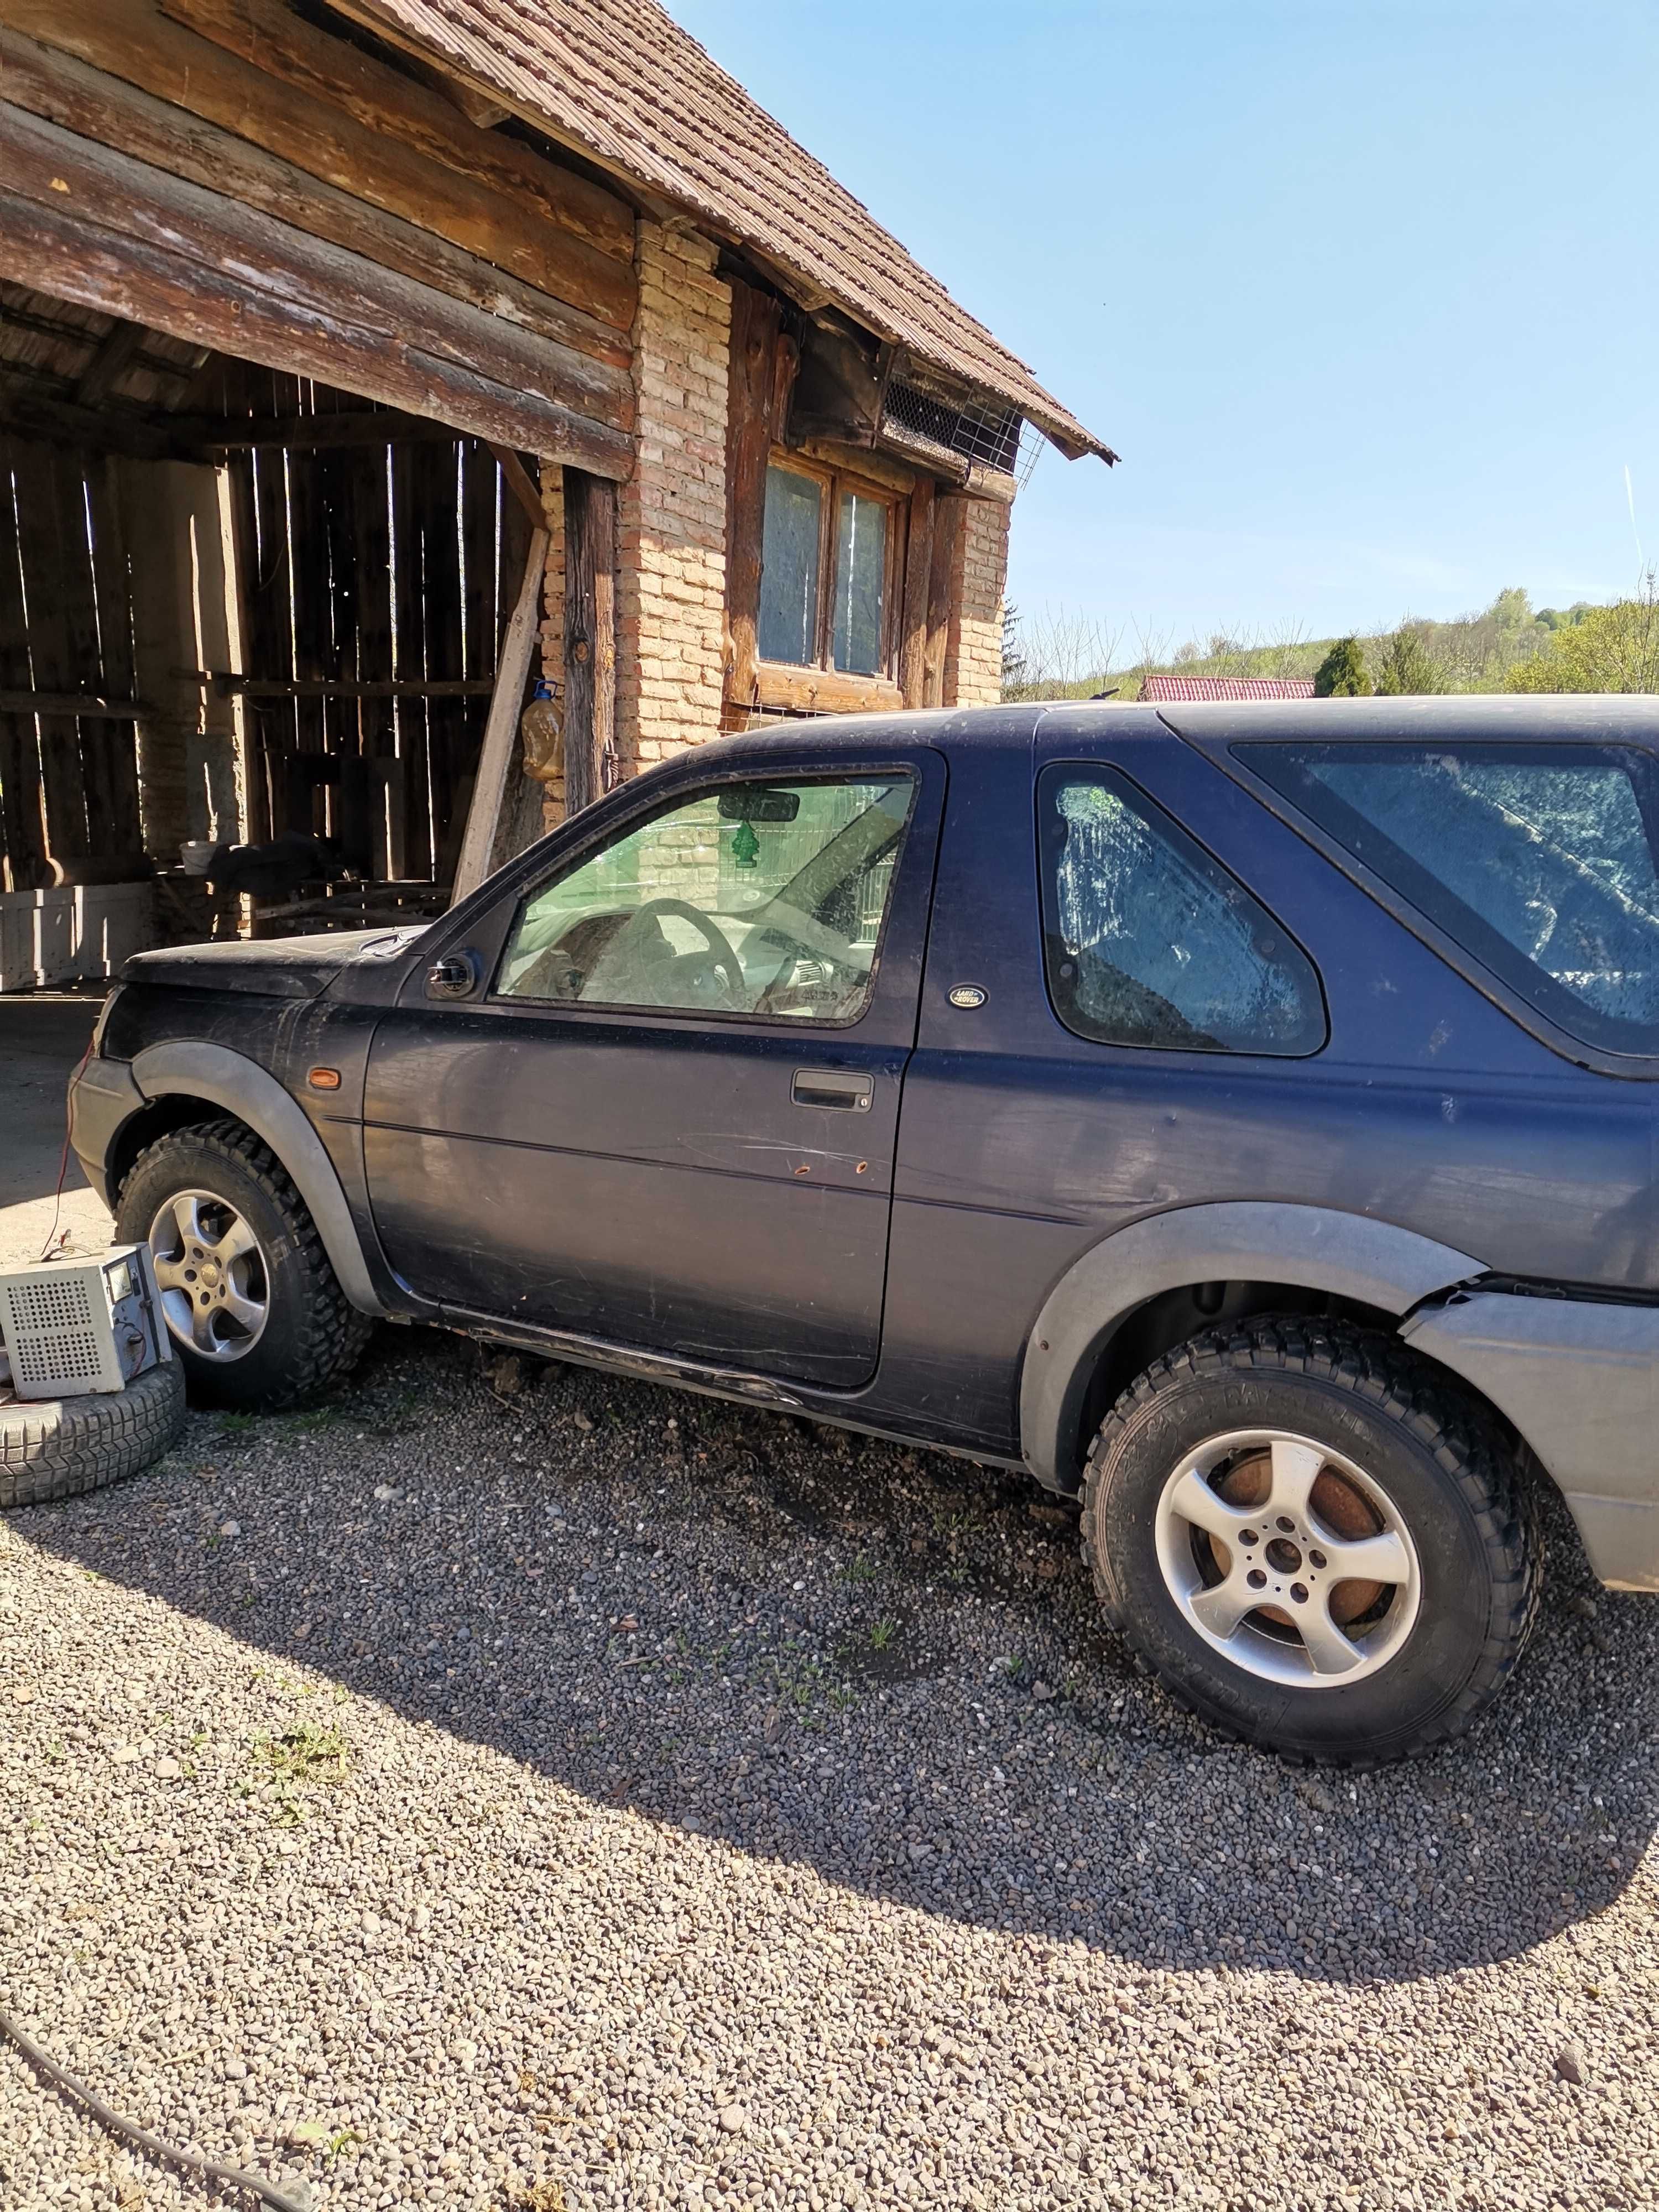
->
[1002, 586, 1593, 699]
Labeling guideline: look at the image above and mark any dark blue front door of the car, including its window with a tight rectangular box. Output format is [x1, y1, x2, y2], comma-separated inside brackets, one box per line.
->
[363, 748, 945, 1389]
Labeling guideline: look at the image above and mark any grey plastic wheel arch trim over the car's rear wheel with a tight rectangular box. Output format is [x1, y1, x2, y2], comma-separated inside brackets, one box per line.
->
[1020, 1201, 1484, 1489]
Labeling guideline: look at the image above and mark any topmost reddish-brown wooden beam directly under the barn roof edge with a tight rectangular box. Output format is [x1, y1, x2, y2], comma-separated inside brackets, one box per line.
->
[163, 0, 633, 265]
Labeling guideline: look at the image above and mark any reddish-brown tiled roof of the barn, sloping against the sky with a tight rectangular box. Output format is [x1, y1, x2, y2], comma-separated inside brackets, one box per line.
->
[343, 0, 1117, 460]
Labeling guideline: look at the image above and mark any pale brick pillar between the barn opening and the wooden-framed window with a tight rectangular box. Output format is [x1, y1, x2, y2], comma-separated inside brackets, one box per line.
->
[617, 219, 732, 774]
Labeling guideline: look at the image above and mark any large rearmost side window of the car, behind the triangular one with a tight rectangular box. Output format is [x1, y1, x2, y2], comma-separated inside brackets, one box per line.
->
[1237, 743, 1659, 1053]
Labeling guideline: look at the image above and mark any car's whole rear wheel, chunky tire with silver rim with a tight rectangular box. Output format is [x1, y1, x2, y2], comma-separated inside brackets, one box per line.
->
[1084, 1318, 1537, 1765]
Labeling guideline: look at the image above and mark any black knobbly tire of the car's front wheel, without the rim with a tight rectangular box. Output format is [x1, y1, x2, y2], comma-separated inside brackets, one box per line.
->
[115, 1119, 374, 1411]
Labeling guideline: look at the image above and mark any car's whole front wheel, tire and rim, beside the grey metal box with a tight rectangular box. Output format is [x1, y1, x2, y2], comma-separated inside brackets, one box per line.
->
[115, 1121, 372, 1407]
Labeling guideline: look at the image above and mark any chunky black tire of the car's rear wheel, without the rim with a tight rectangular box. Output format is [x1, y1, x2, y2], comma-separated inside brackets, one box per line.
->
[1082, 1316, 1542, 1765]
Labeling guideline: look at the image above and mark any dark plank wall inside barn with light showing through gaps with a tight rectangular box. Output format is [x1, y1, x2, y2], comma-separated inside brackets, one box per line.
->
[215, 361, 529, 883]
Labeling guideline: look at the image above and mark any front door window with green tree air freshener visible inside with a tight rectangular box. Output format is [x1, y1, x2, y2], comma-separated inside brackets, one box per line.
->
[495, 772, 916, 1024]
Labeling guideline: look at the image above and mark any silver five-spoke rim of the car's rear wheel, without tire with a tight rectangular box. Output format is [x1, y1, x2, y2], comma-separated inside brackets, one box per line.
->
[1155, 1429, 1422, 1690]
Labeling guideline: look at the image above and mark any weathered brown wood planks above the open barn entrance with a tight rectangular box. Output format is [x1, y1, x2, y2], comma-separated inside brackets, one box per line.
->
[0, 0, 637, 478]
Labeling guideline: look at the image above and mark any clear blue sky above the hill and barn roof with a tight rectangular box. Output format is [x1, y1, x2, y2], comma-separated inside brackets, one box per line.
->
[670, 0, 1659, 659]
